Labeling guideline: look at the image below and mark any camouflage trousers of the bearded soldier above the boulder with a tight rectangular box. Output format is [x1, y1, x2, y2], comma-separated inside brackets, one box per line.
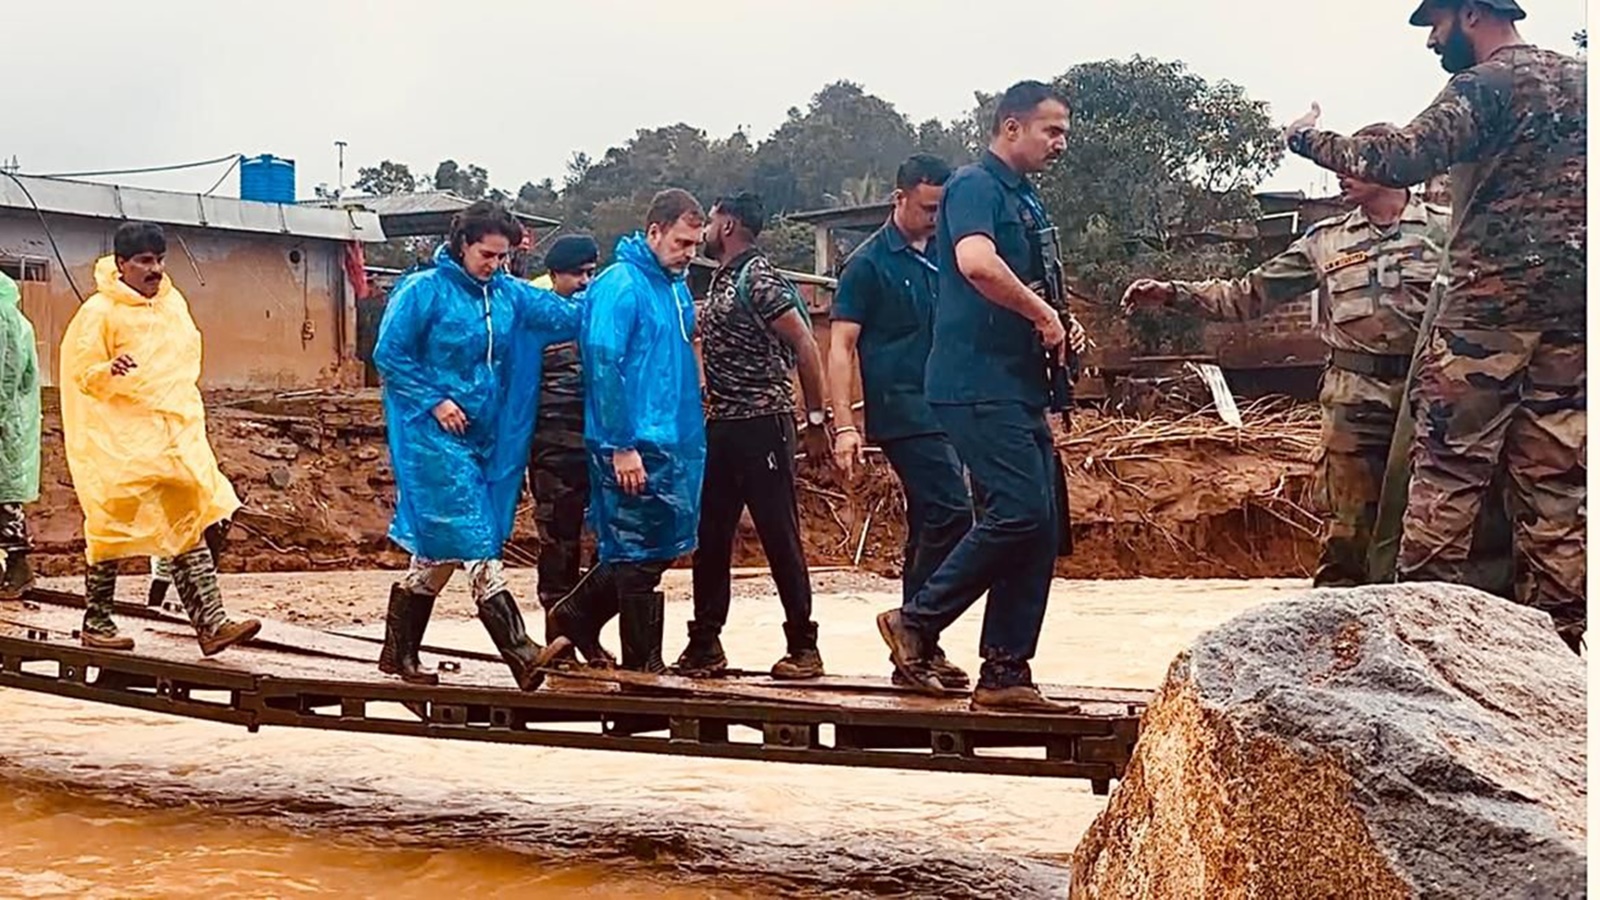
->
[1398, 328, 1589, 645]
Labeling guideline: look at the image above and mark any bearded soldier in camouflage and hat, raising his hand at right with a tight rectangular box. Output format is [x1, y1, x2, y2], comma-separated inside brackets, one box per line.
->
[1286, 0, 1589, 652]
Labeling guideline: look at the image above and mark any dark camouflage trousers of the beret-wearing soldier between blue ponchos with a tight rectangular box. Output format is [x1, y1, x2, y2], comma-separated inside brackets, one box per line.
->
[530, 444, 589, 609]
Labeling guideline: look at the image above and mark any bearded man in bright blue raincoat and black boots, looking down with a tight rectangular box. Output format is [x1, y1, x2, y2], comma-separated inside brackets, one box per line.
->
[547, 189, 706, 673]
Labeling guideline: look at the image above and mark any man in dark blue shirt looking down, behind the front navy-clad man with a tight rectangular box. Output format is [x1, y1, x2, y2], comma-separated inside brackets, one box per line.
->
[827, 154, 973, 689]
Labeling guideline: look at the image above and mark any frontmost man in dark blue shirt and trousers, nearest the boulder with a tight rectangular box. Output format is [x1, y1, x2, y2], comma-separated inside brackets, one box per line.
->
[878, 82, 1082, 709]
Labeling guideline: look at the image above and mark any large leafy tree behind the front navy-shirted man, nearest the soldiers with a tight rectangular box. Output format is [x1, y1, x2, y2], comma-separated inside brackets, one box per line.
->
[1011, 56, 1283, 352]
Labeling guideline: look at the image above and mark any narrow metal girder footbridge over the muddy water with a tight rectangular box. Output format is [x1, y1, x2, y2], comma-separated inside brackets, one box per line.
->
[0, 591, 1149, 794]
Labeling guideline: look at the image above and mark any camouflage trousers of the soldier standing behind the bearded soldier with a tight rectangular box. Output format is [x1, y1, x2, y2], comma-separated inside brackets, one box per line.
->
[1312, 367, 1512, 589]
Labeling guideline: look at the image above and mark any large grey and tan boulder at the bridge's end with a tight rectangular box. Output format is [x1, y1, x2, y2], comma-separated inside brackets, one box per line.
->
[1070, 585, 1589, 900]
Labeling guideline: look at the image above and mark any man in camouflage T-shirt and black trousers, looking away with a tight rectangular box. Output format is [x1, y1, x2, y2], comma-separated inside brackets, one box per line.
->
[677, 192, 830, 679]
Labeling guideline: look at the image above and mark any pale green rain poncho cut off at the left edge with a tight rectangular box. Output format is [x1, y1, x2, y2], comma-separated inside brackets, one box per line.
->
[0, 272, 40, 503]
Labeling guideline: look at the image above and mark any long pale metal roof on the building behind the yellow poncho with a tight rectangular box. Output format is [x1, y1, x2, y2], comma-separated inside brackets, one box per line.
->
[0, 175, 386, 242]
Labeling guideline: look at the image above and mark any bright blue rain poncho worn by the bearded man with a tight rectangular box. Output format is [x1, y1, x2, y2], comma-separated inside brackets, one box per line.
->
[579, 232, 706, 562]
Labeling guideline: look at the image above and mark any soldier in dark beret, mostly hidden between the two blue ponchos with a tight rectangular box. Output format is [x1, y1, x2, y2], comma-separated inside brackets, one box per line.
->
[528, 234, 600, 621]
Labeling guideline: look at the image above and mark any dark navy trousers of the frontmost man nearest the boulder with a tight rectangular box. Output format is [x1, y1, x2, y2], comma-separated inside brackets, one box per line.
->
[902, 402, 1059, 687]
